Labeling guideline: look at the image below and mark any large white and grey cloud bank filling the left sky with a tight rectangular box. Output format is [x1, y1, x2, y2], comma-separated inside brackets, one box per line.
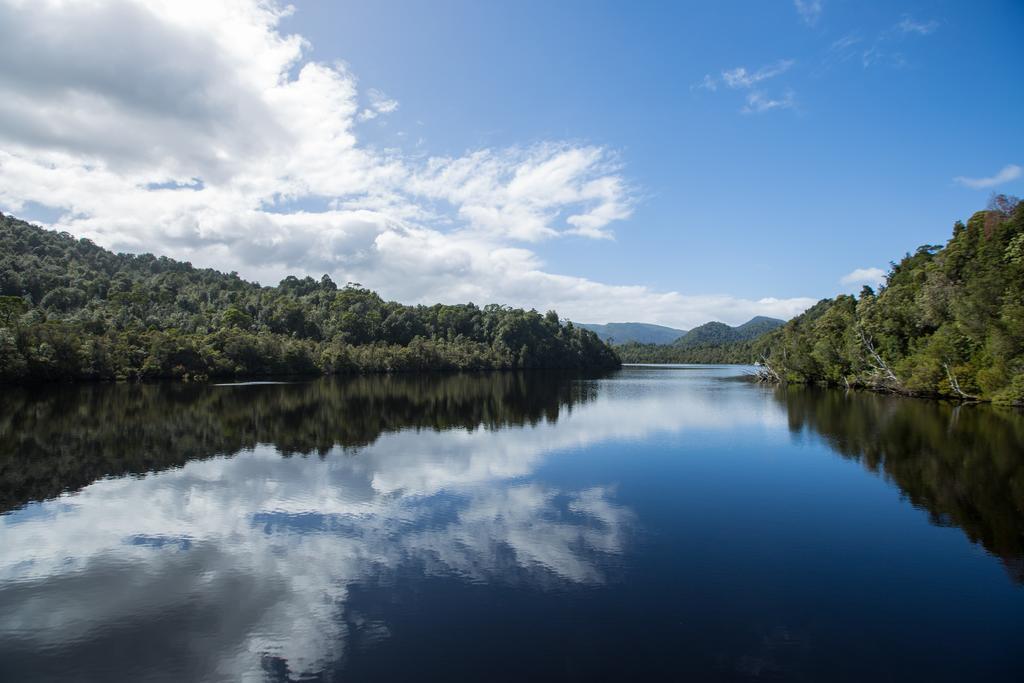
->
[0, 0, 810, 326]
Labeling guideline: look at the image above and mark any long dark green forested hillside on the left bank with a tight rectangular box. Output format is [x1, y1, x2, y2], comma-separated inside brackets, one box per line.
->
[0, 214, 620, 381]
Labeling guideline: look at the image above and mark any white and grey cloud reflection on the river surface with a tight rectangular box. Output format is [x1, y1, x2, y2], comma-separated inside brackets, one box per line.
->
[0, 370, 784, 678]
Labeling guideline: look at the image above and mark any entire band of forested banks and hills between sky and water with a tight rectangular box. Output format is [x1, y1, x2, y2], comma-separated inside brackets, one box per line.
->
[0, 196, 1024, 404]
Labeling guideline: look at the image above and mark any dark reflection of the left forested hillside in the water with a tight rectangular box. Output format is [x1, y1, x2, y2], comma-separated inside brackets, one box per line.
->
[0, 372, 596, 512]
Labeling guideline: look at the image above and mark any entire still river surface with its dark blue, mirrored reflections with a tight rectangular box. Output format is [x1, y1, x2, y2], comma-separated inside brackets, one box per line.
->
[0, 367, 1024, 681]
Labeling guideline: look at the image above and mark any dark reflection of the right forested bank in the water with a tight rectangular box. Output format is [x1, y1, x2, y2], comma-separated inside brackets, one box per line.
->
[774, 386, 1024, 583]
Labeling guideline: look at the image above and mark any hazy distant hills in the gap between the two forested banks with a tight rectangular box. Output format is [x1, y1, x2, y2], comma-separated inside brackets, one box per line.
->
[577, 315, 785, 348]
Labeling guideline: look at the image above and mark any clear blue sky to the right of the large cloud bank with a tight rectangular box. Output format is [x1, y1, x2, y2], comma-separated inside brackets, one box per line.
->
[286, 0, 1024, 297]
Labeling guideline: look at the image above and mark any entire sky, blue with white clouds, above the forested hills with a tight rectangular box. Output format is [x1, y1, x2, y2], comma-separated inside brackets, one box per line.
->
[0, 0, 1024, 327]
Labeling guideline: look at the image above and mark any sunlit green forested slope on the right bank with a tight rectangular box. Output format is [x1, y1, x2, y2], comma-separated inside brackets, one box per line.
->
[753, 196, 1024, 403]
